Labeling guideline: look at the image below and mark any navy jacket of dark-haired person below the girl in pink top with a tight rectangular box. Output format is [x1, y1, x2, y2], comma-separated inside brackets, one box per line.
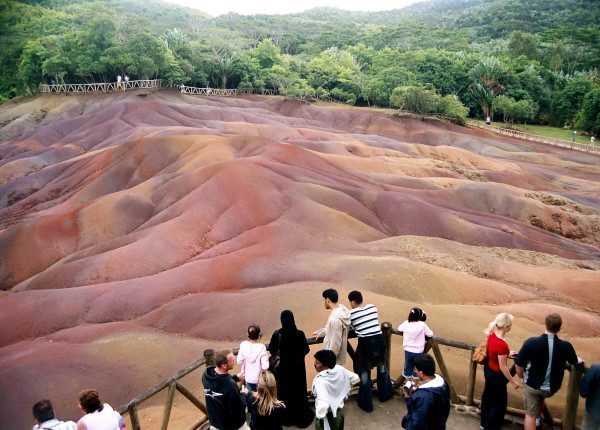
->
[402, 375, 450, 430]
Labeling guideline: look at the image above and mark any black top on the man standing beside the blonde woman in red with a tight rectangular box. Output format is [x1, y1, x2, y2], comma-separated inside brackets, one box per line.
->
[515, 334, 577, 394]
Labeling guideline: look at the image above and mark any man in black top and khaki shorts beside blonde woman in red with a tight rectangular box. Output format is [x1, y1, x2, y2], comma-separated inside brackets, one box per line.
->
[515, 313, 583, 430]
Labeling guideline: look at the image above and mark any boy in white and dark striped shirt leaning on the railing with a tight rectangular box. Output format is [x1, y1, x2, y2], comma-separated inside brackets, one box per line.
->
[348, 291, 394, 412]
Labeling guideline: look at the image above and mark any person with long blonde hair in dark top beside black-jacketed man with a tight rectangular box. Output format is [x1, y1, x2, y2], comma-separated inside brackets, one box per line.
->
[244, 372, 285, 430]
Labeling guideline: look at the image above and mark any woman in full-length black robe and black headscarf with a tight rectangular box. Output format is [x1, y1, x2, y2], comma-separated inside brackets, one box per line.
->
[269, 310, 315, 428]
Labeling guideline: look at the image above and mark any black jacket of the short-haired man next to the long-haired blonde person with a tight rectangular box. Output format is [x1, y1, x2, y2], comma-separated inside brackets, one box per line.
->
[202, 366, 246, 430]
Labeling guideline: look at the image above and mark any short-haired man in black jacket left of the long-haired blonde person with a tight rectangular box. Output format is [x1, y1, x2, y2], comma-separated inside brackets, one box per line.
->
[202, 350, 249, 430]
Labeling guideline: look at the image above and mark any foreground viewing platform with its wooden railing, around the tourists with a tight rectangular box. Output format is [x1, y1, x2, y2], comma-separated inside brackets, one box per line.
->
[118, 323, 584, 430]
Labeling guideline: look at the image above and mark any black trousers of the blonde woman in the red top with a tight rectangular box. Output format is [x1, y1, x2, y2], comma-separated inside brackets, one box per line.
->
[480, 364, 508, 430]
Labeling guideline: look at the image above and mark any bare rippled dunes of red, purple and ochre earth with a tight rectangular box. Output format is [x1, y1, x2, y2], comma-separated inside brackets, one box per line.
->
[0, 91, 600, 428]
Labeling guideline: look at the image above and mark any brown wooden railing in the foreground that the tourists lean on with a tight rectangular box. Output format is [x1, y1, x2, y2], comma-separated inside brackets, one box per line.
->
[118, 322, 584, 430]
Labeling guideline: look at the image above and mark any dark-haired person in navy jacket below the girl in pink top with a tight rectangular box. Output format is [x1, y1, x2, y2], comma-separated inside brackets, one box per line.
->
[402, 354, 450, 430]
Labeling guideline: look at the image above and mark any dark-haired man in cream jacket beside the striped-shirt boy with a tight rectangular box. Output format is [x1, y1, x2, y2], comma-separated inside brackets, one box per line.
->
[313, 288, 350, 366]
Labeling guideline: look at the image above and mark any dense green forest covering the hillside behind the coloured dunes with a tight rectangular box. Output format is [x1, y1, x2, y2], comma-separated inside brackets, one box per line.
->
[0, 0, 600, 134]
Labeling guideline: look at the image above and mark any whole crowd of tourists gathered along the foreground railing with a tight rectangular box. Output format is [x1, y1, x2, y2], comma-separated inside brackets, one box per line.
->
[33, 289, 600, 430]
